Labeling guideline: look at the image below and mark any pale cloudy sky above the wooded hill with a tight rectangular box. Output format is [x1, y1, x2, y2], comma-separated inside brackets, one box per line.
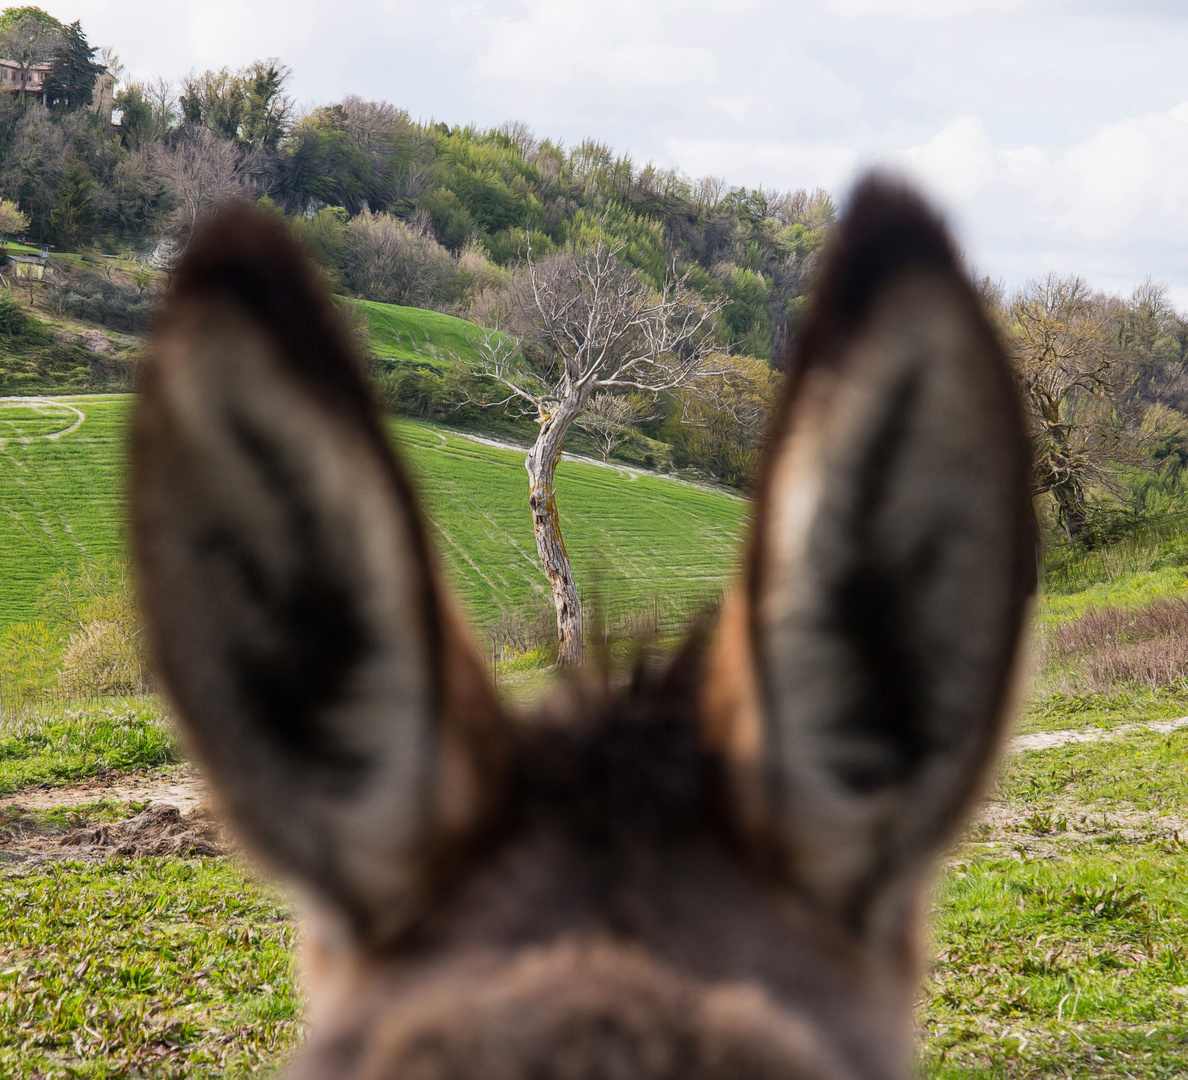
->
[34, 0, 1188, 302]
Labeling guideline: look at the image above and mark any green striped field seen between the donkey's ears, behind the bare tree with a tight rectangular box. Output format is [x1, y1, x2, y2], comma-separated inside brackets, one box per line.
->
[397, 422, 747, 620]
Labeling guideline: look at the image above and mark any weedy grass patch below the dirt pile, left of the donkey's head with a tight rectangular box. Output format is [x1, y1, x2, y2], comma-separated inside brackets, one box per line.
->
[0, 859, 301, 1080]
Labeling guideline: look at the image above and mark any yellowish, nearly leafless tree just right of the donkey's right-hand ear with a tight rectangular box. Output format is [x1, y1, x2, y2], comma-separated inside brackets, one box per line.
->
[1007, 273, 1126, 541]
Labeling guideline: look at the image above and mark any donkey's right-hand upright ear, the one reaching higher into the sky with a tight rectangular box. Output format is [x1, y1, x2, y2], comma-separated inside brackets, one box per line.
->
[710, 179, 1035, 928]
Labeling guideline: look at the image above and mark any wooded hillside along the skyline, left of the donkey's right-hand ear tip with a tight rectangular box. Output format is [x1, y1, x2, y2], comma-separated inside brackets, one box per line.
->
[0, 8, 835, 359]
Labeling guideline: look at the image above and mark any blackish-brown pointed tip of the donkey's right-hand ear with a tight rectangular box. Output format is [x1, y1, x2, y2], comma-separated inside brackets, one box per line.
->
[788, 172, 961, 373]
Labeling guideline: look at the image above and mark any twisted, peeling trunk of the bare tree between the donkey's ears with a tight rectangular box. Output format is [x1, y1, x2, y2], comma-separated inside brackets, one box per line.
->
[524, 399, 586, 668]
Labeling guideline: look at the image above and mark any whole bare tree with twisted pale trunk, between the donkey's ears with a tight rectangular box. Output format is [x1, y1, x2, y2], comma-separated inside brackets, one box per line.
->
[472, 232, 726, 667]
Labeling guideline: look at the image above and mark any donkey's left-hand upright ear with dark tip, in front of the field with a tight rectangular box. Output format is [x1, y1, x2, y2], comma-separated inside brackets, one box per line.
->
[132, 209, 505, 936]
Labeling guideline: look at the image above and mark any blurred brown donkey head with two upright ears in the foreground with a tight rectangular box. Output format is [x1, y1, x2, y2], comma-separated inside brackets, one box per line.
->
[132, 178, 1035, 1080]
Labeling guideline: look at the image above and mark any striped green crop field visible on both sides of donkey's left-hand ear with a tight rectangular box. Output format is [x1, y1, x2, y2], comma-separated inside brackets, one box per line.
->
[0, 396, 746, 626]
